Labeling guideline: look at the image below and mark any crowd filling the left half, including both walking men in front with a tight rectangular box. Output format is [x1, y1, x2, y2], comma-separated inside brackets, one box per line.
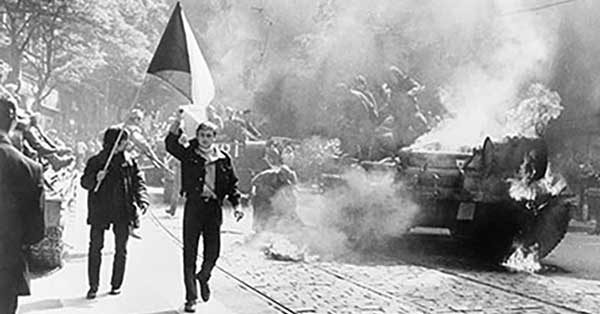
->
[0, 76, 299, 313]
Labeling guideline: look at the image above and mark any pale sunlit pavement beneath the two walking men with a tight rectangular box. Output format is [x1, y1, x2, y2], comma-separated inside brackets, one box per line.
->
[17, 190, 267, 314]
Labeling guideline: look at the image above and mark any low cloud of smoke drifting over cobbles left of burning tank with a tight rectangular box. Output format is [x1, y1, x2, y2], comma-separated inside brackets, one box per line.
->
[265, 168, 418, 258]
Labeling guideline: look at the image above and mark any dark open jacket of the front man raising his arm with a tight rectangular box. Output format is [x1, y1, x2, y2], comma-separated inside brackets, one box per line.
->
[165, 129, 240, 206]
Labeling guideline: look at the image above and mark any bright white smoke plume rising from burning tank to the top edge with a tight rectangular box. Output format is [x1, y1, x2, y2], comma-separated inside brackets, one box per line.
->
[413, 1, 560, 150]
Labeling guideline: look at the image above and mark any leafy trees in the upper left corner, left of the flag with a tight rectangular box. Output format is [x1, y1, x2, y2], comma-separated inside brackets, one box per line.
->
[0, 0, 167, 115]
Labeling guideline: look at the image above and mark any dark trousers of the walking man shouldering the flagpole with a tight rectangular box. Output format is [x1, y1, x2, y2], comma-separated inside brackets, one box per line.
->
[88, 223, 129, 290]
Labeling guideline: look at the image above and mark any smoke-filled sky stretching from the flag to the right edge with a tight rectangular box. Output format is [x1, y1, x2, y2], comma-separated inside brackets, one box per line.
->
[178, 0, 600, 151]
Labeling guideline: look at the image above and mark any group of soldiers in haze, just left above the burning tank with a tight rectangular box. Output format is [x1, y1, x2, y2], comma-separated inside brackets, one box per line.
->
[336, 66, 443, 160]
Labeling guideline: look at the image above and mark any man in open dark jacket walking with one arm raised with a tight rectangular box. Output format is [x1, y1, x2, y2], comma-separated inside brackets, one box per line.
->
[165, 111, 243, 313]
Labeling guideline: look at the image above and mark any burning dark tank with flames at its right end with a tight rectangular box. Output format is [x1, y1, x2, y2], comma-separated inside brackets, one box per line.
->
[395, 137, 572, 260]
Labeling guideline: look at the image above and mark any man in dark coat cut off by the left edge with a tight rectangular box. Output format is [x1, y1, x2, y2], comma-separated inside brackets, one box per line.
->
[0, 96, 45, 313]
